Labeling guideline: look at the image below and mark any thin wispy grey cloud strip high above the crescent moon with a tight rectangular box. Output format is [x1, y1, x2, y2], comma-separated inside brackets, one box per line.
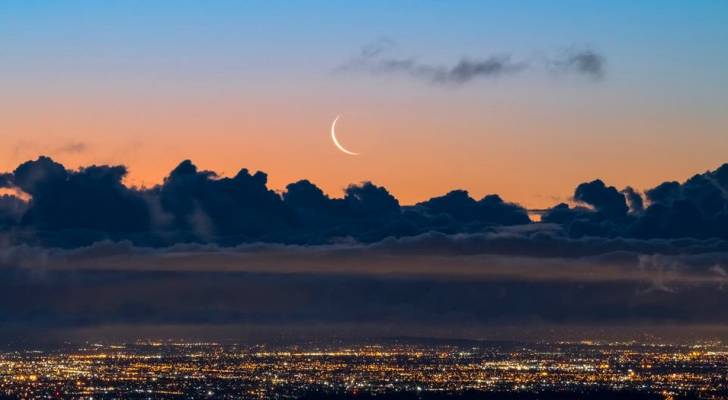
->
[336, 39, 606, 85]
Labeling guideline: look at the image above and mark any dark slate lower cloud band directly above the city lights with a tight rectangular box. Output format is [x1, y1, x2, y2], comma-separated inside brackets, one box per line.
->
[0, 270, 728, 330]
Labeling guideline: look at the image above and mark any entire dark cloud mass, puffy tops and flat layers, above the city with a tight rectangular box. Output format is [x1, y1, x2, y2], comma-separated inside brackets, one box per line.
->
[0, 157, 728, 336]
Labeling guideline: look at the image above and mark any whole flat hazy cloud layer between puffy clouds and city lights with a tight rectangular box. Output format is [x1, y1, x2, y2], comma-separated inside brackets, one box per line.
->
[0, 231, 728, 337]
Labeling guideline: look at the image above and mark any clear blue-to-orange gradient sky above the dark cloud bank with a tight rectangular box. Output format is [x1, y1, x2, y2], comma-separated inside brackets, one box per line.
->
[0, 0, 728, 207]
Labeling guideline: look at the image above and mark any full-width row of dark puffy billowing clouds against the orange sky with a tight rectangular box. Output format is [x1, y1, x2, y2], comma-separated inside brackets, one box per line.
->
[0, 157, 728, 247]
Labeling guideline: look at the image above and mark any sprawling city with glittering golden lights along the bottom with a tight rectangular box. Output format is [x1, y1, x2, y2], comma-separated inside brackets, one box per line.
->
[0, 339, 728, 399]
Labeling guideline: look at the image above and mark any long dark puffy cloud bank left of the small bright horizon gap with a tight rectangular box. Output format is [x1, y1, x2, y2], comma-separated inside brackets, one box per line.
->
[0, 157, 530, 247]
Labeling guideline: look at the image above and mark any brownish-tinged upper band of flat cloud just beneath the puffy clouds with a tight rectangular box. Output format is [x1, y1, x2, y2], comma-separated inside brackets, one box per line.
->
[0, 224, 728, 280]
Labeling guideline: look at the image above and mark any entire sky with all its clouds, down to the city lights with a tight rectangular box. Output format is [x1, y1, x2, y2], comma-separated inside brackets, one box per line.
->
[0, 0, 728, 340]
